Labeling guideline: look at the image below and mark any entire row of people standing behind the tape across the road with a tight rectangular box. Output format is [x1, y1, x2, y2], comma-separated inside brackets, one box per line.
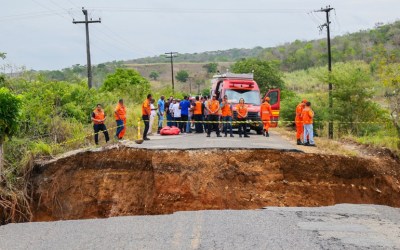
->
[92, 94, 315, 146]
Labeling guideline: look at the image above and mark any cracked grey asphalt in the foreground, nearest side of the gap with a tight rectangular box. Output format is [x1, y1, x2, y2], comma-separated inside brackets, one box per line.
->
[0, 204, 400, 249]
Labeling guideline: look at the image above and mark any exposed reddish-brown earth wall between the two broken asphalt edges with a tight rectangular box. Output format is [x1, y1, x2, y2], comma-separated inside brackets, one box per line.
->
[32, 147, 400, 221]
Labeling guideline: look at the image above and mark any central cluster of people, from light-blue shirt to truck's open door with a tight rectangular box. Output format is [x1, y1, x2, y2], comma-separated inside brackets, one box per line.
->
[158, 94, 272, 137]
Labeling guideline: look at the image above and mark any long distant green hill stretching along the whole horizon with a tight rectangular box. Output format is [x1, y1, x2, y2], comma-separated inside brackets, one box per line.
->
[33, 21, 400, 86]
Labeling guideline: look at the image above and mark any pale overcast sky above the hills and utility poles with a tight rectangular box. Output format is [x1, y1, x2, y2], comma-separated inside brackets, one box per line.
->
[0, 0, 400, 70]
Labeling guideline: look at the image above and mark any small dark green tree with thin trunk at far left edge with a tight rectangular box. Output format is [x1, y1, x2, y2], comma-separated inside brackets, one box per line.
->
[0, 88, 21, 178]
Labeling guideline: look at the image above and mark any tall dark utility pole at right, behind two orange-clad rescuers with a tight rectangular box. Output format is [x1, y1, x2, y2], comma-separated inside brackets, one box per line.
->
[315, 5, 334, 139]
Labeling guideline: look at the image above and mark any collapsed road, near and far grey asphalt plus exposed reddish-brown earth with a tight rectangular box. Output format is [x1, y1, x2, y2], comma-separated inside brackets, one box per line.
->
[0, 133, 400, 249]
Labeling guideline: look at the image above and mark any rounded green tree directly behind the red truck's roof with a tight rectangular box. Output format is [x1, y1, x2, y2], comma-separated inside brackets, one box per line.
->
[231, 58, 284, 94]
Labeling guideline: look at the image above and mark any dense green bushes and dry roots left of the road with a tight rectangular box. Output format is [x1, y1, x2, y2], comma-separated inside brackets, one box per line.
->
[0, 66, 159, 224]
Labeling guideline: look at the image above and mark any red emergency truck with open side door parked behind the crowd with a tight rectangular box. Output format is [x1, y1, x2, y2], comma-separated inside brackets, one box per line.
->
[211, 73, 280, 134]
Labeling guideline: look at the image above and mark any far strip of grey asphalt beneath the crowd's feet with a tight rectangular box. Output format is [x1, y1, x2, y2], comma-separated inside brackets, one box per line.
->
[125, 131, 297, 150]
